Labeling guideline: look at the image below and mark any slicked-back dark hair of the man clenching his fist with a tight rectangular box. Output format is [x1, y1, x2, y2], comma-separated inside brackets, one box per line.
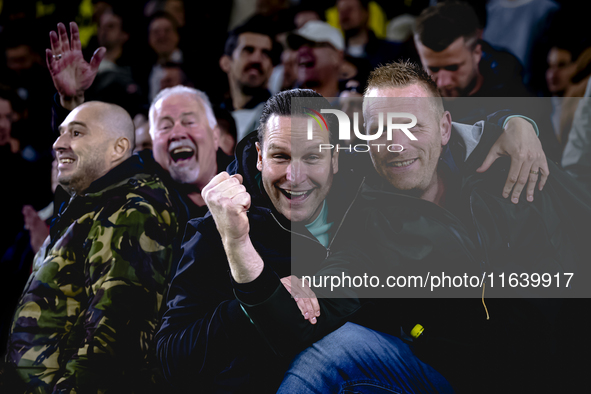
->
[258, 89, 339, 148]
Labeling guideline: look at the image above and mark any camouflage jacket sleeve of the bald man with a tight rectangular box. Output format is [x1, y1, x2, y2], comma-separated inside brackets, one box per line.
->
[54, 193, 178, 393]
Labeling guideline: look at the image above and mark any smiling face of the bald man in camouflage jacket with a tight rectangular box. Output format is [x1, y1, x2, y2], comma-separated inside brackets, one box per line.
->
[53, 105, 111, 194]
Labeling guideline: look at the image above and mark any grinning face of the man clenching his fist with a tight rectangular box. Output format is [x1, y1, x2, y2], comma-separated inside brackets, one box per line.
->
[257, 115, 338, 224]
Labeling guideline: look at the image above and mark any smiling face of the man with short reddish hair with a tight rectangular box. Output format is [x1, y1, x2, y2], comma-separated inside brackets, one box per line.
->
[363, 84, 451, 197]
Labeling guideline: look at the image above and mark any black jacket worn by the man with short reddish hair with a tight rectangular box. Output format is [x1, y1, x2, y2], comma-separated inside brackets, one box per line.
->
[325, 124, 591, 392]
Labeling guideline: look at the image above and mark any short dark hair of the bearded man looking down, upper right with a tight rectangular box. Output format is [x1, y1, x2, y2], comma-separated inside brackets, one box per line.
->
[415, 0, 481, 52]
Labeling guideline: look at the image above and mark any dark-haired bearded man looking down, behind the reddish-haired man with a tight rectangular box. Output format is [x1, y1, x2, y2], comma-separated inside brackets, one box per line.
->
[415, 1, 531, 97]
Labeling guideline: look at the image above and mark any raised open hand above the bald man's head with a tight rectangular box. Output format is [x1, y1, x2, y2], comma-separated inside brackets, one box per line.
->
[45, 22, 107, 110]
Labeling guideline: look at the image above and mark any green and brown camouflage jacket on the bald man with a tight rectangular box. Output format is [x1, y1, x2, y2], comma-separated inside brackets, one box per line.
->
[6, 155, 178, 393]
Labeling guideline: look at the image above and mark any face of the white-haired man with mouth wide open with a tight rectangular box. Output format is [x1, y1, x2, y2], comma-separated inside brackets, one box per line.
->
[152, 93, 219, 189]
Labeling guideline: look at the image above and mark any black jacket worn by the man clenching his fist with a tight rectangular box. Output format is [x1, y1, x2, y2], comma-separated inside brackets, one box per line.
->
[157, 133, 370, 393]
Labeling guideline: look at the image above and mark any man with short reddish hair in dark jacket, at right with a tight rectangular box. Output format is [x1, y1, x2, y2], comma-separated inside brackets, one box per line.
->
[288, 63, 591, 392]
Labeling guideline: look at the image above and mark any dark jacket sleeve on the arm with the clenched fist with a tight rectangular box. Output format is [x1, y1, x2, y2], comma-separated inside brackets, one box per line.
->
[156, 219, 260, 387]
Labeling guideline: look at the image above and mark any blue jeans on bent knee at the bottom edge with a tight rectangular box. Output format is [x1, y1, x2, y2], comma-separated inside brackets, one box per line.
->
[277, 323, 453, 394]
